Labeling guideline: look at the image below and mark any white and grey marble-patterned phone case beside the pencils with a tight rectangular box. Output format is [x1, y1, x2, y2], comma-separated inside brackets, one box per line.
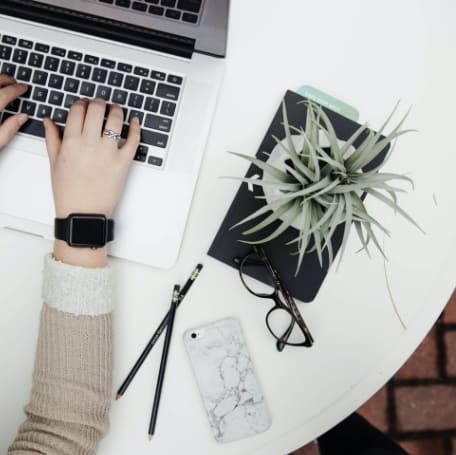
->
[184, 318, 271, 442]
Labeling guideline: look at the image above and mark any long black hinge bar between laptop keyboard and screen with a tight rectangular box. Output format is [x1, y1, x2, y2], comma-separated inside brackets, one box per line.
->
[0, 0, 195, 58]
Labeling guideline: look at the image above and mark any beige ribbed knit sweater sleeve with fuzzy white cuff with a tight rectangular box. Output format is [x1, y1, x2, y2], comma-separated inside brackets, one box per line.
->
[8, 256, 112, 455]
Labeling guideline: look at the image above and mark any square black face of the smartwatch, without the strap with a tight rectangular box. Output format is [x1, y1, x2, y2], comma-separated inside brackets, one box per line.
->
[70, 215, 106, 247]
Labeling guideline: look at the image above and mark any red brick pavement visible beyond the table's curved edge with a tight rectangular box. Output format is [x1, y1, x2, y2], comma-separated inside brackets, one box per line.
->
[291, 290, 456, 455]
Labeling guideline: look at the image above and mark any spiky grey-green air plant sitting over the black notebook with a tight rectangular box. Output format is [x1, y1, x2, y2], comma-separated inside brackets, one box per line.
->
[233, 101, 421, 274]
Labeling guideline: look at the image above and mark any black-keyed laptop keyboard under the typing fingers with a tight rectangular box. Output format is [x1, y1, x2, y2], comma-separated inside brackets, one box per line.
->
[0, 35, 184, 167]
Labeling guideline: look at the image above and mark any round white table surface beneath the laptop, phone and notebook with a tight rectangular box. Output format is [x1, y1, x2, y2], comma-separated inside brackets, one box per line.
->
[0, 0, 456, 455]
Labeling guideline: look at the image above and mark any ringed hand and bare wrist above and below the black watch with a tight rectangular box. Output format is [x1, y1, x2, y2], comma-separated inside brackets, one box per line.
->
[44, 99, 140, 267]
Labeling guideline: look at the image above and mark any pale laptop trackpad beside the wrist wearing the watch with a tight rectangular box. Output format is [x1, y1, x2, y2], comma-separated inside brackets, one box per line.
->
[0, 146, 54, 227]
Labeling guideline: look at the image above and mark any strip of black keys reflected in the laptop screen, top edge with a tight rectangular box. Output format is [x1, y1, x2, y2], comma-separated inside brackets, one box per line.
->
[97, 0, 203, 24]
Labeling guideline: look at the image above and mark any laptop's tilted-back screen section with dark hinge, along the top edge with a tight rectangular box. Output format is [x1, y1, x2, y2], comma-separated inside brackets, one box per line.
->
[0, 0, 229, 58]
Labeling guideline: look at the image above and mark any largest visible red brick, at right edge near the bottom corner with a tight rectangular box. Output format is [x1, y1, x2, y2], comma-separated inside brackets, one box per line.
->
[394, 385, 456, 431]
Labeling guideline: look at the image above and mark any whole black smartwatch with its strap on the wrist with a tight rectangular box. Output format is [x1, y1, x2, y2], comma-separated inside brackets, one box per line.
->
[54, 213, 114, 249]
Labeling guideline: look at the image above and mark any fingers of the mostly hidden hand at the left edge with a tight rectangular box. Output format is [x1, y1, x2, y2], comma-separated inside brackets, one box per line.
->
[0, 74, 28, 149]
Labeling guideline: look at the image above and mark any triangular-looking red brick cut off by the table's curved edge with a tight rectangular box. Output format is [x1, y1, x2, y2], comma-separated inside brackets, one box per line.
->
[396, 327, 439, 379]
